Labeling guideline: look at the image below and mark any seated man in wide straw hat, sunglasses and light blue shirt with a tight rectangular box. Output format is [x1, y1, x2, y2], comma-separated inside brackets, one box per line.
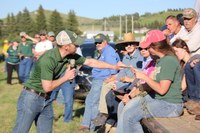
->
[93, 33, 143, 130]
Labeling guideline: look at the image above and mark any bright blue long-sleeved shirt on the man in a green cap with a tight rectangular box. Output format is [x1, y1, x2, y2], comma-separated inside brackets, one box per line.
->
[92, 45, 120, 80]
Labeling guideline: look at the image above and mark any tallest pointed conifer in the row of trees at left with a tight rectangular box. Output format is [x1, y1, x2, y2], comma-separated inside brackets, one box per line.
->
[36, 5, 47, 32]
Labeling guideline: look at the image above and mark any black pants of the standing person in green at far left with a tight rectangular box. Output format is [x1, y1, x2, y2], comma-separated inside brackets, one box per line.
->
[6, 63, 21, 84]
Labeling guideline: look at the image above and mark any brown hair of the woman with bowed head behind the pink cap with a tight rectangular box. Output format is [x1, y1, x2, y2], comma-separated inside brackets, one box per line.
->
[172, 39, 190, 68]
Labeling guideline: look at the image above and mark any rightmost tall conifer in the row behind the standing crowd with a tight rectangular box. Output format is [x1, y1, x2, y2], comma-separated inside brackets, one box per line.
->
[66, 10, 82, 35]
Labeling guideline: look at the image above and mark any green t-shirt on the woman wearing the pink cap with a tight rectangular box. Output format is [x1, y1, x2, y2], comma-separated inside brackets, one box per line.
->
[153, 55, 183, 103]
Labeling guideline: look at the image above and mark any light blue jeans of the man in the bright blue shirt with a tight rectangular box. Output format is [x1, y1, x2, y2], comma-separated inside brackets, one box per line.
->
[81, 79, 104, 130]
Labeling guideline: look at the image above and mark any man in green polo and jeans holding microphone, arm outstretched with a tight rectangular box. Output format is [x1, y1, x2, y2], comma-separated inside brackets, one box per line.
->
[13, 30, 124, 133]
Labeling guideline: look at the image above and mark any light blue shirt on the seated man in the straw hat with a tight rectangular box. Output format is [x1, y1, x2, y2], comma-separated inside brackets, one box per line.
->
[117, 49, 143, 90]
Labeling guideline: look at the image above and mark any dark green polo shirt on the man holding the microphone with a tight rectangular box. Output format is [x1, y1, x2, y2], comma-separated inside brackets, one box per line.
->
[25, 48, 85, 93]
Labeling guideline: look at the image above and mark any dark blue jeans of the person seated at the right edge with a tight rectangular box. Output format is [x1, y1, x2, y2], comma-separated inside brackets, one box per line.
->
[185, 62, 200, 102]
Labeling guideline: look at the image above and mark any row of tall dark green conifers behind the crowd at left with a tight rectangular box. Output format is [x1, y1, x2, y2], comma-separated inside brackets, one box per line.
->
[0, 5, 82, 41]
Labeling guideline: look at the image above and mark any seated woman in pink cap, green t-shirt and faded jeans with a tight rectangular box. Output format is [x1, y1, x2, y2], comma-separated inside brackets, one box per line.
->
[116, 30, 183, 133]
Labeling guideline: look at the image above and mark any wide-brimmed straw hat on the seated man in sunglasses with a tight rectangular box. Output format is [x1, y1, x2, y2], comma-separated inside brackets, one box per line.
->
[116, 32, 139, 45]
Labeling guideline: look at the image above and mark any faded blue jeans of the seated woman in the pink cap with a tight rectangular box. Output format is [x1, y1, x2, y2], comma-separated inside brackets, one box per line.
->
[116, 95, 183, 133]
